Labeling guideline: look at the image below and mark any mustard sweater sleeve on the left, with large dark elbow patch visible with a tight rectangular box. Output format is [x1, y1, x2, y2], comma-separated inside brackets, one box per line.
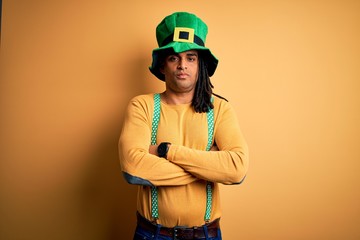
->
[119, 96, 198, 186]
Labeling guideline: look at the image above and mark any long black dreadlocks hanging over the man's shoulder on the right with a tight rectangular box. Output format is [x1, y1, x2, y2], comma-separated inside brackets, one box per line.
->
[191, 51, 227, 113]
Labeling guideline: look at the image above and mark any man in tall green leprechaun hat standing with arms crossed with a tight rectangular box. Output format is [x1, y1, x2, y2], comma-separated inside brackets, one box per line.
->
[119, 12, 248, 240]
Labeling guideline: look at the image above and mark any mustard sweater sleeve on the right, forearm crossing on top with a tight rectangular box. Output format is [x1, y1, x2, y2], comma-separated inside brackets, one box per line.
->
[168, 98, 249, 184]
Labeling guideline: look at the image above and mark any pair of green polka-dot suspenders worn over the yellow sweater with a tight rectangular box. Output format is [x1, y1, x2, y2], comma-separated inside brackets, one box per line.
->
[151, 93, 214, 222]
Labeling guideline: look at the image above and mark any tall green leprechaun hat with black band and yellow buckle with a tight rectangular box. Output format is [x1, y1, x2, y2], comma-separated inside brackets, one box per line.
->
[149, 12, 218, 81]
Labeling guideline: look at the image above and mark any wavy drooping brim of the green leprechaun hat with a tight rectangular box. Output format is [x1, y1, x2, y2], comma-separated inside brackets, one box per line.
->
[149, 42, 219, 81]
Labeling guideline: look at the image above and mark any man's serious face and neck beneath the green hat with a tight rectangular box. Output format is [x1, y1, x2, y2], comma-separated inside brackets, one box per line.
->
[160, 50, 199, 93]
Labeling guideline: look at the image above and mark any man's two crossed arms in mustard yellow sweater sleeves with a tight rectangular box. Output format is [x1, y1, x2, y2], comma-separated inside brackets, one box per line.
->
[119, 95, 248, 186]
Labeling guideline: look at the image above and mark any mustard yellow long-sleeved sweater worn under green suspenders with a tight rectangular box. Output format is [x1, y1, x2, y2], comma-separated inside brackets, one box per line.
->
[119, 94, 248, 227]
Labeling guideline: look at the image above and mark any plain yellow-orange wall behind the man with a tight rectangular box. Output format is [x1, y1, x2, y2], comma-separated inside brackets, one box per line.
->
[0, 0, 360, 240]
